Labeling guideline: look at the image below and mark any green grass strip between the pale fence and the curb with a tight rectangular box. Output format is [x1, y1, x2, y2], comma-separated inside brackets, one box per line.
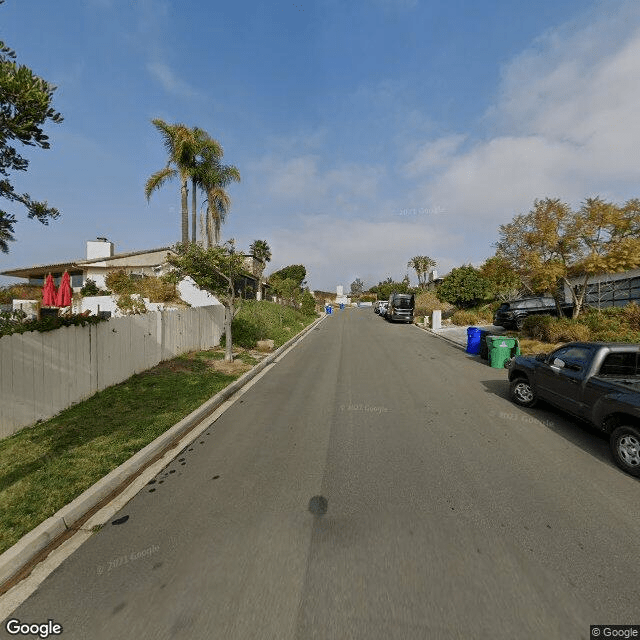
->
[0, 349, 258, 553]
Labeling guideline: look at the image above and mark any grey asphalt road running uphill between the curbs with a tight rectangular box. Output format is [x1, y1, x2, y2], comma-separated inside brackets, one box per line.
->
[0, 309, 640, 640]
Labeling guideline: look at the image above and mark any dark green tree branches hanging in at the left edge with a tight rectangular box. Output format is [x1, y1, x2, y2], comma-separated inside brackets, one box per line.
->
[0, 16, 62, 253]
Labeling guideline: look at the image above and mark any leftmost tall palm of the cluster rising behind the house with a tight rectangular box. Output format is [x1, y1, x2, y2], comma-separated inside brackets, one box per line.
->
[144, 118, 196, 244]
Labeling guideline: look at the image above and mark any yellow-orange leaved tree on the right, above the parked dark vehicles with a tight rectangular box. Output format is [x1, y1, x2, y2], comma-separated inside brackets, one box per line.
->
[495, 197, 640, 318]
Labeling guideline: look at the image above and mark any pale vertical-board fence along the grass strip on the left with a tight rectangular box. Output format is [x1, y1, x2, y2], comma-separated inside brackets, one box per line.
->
[0, 305, 224, 439]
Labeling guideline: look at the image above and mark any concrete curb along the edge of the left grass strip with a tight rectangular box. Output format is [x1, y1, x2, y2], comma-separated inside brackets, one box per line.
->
[0, 314, 326, 593]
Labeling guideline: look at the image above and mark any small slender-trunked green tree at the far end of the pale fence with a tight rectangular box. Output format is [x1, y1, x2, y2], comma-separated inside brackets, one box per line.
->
[168, 240, 244, 362]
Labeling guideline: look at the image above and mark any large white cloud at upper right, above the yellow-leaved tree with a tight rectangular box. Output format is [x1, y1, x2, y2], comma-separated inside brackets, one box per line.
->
[406, 4, 640, 226]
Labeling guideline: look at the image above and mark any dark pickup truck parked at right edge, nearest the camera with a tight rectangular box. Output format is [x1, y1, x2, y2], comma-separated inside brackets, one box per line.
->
[509, 342, 640, 477]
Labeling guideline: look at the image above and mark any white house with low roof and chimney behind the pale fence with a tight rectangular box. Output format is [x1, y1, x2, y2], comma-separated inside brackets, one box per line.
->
[1, 237, 267, 312]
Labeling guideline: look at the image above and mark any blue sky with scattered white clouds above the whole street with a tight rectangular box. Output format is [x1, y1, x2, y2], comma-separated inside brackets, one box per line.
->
[0, 0, 640, 290]
